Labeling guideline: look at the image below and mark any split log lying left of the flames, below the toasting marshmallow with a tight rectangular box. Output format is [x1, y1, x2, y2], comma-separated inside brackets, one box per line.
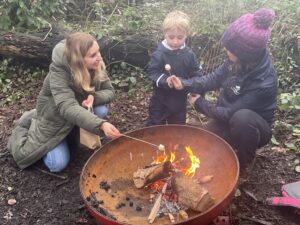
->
[133, 161, 172, 188]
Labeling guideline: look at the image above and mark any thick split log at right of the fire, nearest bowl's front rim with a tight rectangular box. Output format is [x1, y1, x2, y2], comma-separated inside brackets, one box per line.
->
[171, 173, 214, 212]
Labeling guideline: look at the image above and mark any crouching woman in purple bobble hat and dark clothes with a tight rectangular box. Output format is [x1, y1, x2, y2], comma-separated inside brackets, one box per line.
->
[172, 8, 277, 169]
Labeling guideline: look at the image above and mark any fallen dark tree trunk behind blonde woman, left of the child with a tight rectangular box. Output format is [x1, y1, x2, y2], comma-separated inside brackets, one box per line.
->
[0, 30, 156, 68]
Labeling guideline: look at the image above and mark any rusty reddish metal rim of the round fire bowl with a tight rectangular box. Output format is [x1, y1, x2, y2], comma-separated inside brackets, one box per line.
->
[79, 125, 240, 225]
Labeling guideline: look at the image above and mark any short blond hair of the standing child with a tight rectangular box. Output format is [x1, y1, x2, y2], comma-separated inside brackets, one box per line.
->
[162, 10, 190, 34]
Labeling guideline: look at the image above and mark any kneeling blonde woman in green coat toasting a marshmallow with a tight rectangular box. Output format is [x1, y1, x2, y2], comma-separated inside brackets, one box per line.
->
[8, 33, 120, 172]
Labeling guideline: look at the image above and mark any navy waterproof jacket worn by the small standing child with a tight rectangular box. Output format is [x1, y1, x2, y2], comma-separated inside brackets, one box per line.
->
[147, 43, 202, 112]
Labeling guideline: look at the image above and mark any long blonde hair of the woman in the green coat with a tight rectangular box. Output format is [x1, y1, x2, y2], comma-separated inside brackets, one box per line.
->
[64, 32, 106, 93]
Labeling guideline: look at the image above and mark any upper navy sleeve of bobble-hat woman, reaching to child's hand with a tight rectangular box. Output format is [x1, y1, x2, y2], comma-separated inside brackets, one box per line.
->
[181, 60, 231, 94]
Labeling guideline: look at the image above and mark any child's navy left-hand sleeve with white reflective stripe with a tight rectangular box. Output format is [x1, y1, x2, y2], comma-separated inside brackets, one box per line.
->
[147, 51, 170, 89]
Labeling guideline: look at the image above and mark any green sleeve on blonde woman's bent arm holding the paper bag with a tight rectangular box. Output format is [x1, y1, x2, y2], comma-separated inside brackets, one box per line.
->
[94, 77, 115, 105]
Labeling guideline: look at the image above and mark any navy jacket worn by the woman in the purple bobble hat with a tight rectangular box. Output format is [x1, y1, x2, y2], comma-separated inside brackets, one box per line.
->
[182, 50, 278, 124]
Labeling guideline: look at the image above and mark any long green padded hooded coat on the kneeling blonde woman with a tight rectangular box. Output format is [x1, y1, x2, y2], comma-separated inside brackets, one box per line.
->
[7, 40, 115, 169]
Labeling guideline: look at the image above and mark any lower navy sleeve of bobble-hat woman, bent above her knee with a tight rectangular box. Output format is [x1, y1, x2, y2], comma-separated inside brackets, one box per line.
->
[195, 90, 265, 122]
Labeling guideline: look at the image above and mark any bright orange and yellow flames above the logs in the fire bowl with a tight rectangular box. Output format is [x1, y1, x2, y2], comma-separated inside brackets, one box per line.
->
[154, 146, 200, 177]
